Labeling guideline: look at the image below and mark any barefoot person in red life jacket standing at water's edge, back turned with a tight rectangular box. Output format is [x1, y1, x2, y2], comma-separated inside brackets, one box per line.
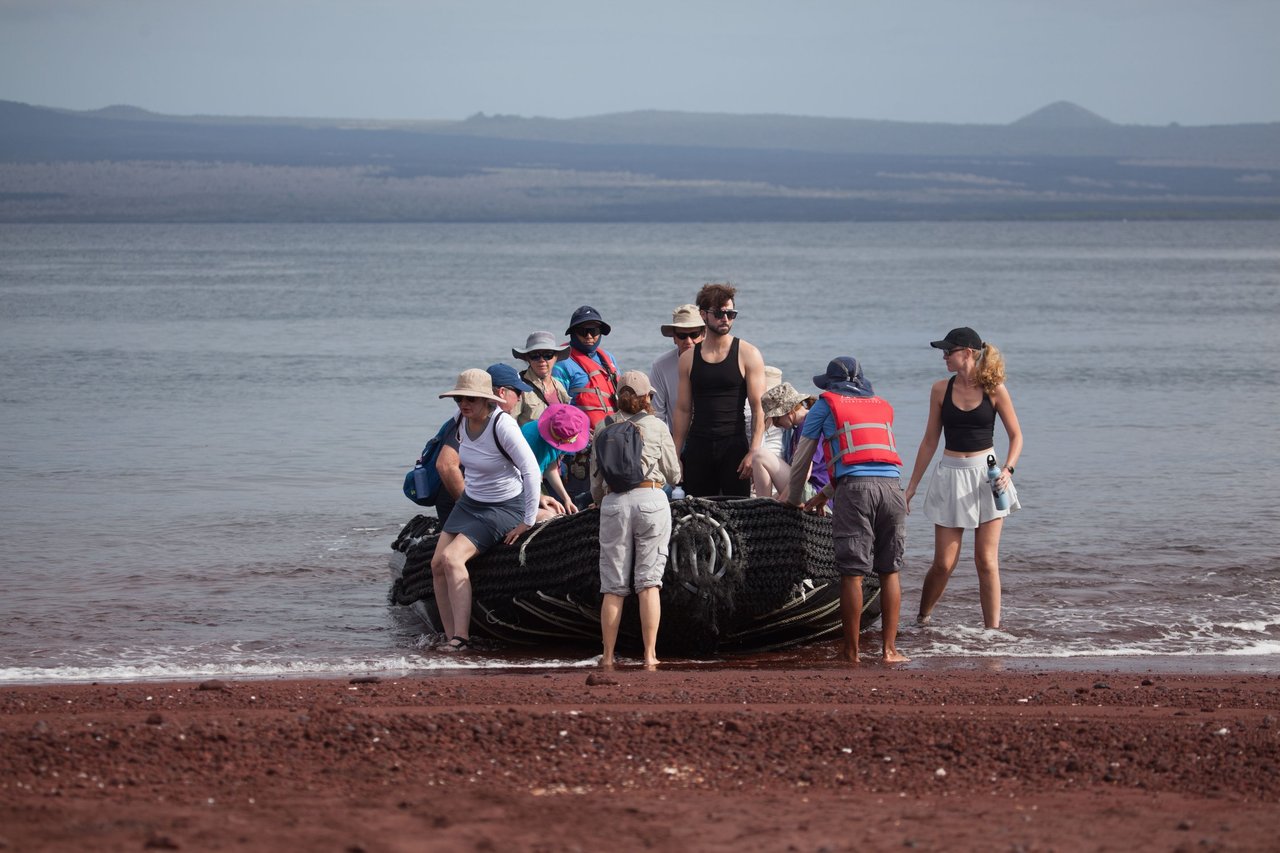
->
[788, 356, 908, 663]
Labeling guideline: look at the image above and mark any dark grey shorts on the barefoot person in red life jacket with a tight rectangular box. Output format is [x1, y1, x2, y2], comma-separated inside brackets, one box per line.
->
[831, 476, 906, 578]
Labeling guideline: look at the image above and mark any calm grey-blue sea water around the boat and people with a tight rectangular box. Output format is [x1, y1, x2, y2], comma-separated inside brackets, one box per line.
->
[0, 217, 1280, 683]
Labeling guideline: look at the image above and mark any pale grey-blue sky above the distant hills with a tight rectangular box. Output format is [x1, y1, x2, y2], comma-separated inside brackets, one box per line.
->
[0, 0, 1280, 124]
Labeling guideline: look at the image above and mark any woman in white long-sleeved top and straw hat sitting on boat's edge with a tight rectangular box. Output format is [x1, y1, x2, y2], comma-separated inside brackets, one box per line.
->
[431, 368, 541, 652]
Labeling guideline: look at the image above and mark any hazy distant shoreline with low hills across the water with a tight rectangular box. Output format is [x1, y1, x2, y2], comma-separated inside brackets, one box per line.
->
[0, 101, 1280, 223]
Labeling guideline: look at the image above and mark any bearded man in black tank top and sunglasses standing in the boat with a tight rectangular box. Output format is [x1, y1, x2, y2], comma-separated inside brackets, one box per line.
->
[672, 284, 765, 497]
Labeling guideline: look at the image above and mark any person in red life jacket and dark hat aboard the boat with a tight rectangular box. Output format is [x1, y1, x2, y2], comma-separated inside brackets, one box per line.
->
[552, 305, 622, 506]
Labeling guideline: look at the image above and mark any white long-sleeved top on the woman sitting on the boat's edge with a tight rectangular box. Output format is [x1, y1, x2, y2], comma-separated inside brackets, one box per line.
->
[458, 410, 543, 525]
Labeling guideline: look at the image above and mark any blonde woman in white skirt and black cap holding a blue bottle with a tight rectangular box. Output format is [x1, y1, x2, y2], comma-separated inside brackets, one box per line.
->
[906, 327, 1023, 628]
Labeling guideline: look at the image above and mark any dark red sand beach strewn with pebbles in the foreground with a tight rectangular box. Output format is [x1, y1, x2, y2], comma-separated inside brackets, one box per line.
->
[0, 665, 1280, 852]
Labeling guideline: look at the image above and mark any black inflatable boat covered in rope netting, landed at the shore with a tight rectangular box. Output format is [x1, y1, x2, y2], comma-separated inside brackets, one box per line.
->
[390, 498, 878, 651]
